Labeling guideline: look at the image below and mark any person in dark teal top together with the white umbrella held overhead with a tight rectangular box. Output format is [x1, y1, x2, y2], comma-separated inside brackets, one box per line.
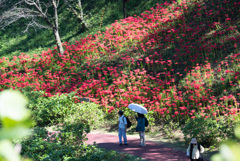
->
[128, 103, 147, 147]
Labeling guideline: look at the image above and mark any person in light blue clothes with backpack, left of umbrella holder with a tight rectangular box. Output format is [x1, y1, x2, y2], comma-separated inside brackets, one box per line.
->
[118, 110, 128, 146]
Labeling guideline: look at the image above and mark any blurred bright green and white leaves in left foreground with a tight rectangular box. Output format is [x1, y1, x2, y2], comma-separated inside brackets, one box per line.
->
[0, 90, 32, 161]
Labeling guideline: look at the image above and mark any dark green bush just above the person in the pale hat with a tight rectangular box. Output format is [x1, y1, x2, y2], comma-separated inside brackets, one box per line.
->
[182, 116, 233, 147]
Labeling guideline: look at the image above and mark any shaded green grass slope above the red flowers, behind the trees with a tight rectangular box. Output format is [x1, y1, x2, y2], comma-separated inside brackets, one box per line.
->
[0, 0, 170, 57]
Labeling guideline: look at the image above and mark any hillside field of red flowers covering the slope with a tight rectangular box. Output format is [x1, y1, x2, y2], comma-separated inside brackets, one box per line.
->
[0, 0, 240, 119]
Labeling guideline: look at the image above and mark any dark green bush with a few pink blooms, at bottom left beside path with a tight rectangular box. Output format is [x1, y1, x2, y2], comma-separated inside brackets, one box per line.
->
[16, 123, 90, 161]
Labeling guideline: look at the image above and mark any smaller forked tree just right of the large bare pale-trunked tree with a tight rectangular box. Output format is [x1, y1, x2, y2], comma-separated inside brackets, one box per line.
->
[65, 0, 88, 30]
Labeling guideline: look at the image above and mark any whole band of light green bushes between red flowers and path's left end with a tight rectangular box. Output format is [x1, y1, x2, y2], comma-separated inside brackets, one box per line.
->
[25, 90, 103, 128]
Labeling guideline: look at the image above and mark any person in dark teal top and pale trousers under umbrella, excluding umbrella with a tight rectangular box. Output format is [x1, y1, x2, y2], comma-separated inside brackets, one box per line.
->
[135, 113, 146, 147]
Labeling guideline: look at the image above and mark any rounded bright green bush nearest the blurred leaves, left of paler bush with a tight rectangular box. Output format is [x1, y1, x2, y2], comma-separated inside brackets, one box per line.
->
[28, 92, 76, 126]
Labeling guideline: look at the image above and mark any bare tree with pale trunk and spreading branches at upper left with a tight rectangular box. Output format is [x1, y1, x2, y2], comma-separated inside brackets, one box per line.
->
[0, 0, 64, 55]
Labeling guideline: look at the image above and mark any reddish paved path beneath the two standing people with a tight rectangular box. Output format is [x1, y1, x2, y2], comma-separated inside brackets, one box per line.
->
[86, 133, 206, 161]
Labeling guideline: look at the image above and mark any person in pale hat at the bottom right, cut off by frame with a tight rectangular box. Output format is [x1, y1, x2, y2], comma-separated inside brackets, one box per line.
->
[187, 138, 204, 161]
